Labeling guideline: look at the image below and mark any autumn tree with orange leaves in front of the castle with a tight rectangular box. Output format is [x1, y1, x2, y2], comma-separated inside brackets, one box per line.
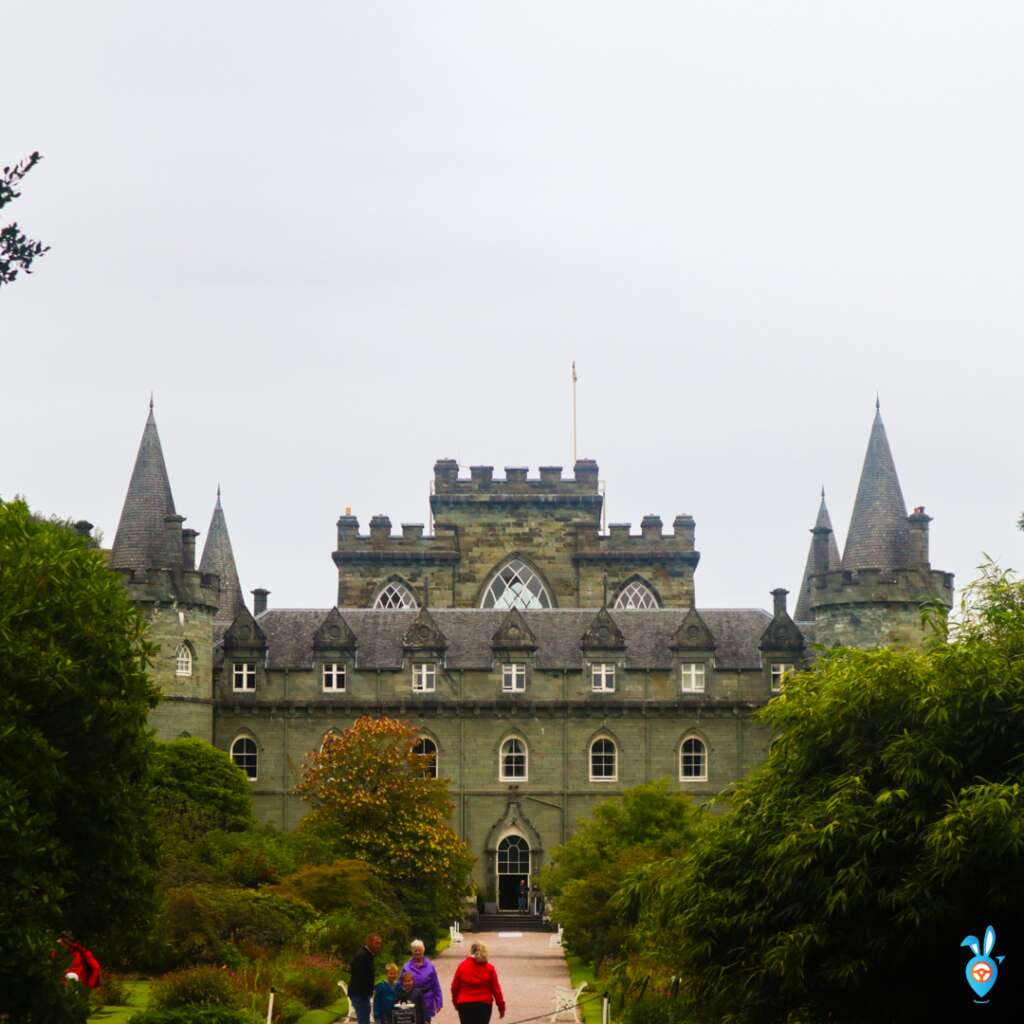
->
[296, 717, 473, 941]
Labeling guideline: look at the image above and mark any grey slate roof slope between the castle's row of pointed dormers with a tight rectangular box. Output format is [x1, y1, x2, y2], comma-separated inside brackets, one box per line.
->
[237, 608, 772, 670]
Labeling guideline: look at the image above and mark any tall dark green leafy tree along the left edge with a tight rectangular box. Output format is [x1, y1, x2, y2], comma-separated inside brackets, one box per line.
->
[0, 502, 157, 1024]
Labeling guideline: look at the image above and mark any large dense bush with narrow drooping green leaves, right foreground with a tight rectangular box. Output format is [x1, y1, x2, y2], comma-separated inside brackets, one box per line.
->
[616, 567, 1024, 1024]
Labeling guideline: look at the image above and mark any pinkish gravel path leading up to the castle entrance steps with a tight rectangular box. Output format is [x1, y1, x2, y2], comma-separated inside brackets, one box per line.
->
[434, 932, 587, 1024]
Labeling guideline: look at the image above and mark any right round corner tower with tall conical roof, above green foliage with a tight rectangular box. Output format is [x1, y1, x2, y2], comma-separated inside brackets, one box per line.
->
[801, 401, 953, 647]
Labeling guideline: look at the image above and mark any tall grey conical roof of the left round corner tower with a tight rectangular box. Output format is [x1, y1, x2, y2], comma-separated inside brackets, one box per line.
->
[110, 398, 174, 569]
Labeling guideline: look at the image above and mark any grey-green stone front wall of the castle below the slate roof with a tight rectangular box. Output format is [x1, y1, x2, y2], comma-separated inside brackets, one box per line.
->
[215, 664, 771, 889]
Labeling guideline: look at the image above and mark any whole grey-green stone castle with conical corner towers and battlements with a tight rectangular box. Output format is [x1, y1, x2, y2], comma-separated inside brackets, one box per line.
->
[110, 402, 952, 908]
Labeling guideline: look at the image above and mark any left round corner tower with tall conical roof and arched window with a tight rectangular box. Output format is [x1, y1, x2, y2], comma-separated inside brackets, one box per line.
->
[110, 399, 220, 742]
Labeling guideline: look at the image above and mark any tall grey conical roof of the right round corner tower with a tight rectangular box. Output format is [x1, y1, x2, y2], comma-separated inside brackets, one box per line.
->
[843, 401, 910, 569]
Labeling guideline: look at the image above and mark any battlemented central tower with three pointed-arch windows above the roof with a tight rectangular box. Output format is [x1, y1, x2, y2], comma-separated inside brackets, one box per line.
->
[333, 459, 700, 608]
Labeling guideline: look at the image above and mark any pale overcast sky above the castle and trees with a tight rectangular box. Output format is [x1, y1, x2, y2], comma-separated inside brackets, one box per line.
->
[0, 0, 1024, 607]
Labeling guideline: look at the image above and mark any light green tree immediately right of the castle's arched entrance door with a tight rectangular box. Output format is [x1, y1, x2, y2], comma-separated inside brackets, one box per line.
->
[541, 779, 699, 968]
